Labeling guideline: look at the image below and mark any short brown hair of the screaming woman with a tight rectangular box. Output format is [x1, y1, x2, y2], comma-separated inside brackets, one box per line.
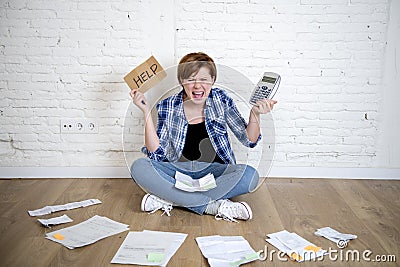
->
[177, 52, 217, 83]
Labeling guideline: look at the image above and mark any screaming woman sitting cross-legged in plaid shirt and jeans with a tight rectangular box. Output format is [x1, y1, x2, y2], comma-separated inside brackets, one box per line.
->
[130, 53, 276, 222]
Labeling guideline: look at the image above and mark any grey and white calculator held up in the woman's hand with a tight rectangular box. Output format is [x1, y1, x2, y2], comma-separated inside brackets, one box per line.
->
[250, 72, 281, 105]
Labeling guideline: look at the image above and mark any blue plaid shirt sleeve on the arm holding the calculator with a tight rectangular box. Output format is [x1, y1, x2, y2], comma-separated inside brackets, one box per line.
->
[225, 95, 262, 148]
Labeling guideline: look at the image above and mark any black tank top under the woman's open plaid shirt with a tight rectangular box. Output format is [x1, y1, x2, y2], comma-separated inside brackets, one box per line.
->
[179, 121, 224, 163]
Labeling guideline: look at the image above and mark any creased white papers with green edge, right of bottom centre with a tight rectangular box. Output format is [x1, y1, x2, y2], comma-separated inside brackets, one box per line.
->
[196, 235, 259, 267]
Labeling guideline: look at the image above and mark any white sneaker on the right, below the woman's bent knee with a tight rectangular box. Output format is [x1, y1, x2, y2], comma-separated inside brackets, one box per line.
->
[215, 199, 253, 222]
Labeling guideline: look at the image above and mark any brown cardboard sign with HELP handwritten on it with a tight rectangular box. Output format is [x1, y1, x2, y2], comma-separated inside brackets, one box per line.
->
[124, 56, 167, 93]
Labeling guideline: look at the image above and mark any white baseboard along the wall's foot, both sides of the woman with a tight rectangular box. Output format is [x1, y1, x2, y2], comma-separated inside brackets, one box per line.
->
[0, 167, 400, 180]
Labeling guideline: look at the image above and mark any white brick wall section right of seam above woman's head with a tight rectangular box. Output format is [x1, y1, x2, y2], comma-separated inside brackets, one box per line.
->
[176, 0, 400, 170]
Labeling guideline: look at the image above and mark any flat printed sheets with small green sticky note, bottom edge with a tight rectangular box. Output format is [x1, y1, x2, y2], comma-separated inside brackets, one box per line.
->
[111, 230, 187, 266]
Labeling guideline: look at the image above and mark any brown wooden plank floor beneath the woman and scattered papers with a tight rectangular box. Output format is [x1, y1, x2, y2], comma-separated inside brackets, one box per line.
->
[0, 178, 400, 266]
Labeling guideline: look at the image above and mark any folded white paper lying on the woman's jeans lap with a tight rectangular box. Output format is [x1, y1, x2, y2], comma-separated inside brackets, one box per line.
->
[175, 171, 217, 192]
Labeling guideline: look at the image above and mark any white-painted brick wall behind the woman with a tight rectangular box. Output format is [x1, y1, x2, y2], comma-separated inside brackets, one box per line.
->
[0, 0, 400, 172]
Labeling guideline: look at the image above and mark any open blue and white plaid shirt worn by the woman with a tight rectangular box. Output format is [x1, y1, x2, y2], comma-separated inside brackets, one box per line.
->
[142, 88, 261, 164]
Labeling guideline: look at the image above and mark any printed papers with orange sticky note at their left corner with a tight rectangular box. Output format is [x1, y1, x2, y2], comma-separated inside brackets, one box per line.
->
[46, 215, 129, 249]
